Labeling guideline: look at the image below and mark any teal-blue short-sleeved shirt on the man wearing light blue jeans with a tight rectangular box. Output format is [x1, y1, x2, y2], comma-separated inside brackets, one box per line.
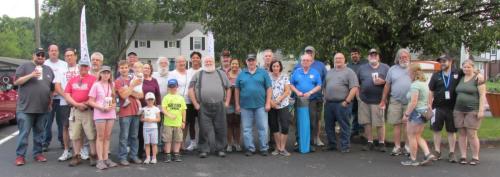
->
[235, 68, 271, 109]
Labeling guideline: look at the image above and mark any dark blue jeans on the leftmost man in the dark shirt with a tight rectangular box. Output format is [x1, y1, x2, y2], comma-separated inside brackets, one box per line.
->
[16, 112, 50, 157]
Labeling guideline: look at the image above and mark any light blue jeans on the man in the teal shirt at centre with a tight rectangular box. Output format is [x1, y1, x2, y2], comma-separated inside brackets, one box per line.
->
[241, 107, 269, 152]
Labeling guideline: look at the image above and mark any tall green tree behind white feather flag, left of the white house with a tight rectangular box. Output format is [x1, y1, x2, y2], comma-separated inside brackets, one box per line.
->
[42, 0, 155, 64]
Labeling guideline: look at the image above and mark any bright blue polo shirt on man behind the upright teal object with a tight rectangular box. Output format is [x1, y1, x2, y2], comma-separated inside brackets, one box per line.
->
[290, 67, 322, 100]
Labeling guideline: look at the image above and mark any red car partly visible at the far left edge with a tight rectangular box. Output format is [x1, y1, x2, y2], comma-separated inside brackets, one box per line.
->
[0, 72, 17, 124]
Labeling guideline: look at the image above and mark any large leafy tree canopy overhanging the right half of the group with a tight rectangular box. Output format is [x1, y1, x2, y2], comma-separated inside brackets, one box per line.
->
[189, 0, 500, 63]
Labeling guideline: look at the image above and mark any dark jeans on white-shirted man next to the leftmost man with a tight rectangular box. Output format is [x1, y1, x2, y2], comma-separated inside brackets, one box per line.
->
[42, 99, 64, 147]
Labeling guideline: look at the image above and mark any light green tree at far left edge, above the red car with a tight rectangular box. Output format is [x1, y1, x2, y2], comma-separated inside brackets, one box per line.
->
[0, 15, 35, 59]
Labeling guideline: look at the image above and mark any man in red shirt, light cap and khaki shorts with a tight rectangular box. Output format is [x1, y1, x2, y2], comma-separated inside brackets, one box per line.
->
[64, 60, 96, 166]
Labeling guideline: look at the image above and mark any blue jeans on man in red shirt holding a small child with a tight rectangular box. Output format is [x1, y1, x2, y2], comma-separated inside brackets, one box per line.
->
[118, 116, 140, 161]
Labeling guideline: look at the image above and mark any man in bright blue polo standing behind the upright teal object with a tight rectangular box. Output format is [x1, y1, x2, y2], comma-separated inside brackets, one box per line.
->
[290, 54, 322, 151]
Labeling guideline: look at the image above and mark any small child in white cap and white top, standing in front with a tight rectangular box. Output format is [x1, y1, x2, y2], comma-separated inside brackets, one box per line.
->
[141, 92, 161, 164]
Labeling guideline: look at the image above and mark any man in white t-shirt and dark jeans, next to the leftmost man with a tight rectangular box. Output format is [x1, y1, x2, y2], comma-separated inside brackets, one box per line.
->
[42, 44, 68, 152]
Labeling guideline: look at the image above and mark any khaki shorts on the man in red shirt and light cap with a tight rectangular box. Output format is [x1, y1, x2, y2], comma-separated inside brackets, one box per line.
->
[68, 108, 95, 140]
